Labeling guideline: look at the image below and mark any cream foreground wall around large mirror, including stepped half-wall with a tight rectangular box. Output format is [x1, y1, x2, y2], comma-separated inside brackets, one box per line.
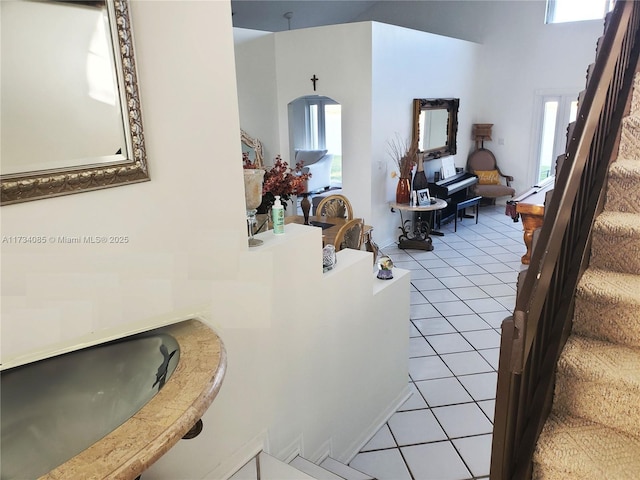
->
[1, 1, 409, 480]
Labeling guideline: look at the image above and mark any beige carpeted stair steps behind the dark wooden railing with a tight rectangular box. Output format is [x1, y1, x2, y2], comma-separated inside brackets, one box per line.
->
[533, 74, 640, 480]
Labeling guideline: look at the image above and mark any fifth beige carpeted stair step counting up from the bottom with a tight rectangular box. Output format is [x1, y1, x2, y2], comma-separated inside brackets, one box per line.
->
[605, 159, 640, 213]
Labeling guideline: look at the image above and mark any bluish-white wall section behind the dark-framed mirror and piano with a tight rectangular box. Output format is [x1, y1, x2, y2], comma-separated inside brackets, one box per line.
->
[371, 23, 480, 245]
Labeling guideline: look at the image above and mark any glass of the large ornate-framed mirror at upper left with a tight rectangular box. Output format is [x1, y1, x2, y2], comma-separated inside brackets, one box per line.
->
[0, 0, 126, 174]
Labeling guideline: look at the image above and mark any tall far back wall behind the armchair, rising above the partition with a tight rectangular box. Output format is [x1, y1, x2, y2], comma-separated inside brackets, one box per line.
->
[360, 0, 603, 191]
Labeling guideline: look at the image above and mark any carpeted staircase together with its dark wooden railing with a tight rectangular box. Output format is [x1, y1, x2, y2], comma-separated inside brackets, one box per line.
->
[491, 0, 640, 480]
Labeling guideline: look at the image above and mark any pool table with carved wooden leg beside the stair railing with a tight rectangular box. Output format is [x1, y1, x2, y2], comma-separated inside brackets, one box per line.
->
[505, 176, 556, 265]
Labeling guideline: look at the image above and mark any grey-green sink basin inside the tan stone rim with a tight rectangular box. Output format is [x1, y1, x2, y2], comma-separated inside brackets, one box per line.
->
[0, 327, 180, 480]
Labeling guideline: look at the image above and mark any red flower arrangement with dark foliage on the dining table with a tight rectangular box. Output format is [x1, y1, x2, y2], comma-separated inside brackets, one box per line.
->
[242, 152, 311, 213]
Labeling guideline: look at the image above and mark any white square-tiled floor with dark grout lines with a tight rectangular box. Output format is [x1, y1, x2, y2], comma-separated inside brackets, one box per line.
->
[350, 205, 526, 480]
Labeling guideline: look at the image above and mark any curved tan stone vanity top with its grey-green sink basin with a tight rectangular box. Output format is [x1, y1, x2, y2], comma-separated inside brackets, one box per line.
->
[1, 319, 226, 480]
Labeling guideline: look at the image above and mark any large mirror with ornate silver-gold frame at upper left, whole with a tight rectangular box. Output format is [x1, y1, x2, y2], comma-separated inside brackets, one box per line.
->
[0, 0, 149, 205]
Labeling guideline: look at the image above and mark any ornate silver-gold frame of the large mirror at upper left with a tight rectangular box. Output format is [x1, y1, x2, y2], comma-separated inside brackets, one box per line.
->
[0, 0, 149, 205]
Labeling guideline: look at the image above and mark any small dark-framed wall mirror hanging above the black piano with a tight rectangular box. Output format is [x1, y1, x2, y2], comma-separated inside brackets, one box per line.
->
[413, 98, 460, 160]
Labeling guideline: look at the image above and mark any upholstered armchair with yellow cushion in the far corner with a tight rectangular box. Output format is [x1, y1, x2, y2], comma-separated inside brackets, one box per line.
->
[467, 148, 516, 203]
